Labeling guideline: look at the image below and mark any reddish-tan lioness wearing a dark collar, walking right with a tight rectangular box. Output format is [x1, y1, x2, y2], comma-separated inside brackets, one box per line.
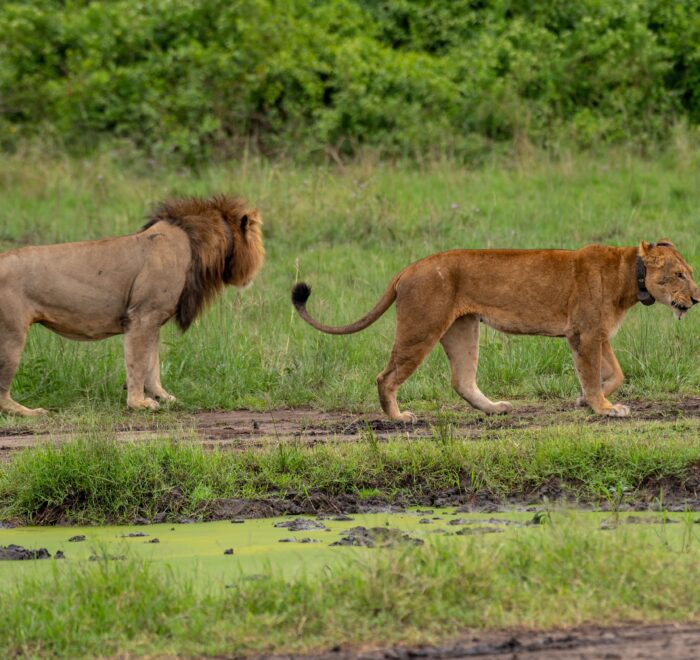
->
[292, 241, 700, 422]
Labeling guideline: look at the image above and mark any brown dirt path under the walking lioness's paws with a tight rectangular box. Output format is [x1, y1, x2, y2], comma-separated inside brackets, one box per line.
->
[0, 397, 700, 460]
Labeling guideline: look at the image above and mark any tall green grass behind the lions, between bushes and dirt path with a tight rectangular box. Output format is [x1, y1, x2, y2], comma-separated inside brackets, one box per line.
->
[0, 145, 700, 424]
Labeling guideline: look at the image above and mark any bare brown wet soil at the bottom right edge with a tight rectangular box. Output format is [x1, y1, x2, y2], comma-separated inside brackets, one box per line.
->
[264, 625, 700, 660]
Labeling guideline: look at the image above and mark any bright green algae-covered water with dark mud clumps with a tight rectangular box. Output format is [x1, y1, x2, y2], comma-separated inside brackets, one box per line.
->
[0, 509, 684, 585]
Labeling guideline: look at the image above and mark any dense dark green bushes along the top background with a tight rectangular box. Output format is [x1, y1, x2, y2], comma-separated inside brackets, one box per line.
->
[0, 0, 700, 162]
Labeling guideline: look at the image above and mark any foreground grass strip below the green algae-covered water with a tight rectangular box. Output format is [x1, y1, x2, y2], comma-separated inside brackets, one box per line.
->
[0, 515, 700, 657]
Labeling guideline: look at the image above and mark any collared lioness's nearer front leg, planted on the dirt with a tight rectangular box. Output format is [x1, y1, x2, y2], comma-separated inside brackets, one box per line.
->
[567, 333, 630, 417]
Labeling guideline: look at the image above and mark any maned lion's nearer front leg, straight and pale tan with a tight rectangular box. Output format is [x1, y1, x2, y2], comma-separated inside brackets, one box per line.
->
[124, 318, 160, 410]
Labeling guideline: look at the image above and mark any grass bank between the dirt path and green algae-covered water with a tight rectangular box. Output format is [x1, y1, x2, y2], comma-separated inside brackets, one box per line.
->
[0, 420, 700, 524]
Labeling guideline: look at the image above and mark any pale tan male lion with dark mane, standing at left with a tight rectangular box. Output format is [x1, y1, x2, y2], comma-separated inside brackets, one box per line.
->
[0, 195, 265, 415]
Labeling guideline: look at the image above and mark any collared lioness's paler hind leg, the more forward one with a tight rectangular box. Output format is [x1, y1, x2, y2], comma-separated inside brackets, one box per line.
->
[440, 315, 513, 414]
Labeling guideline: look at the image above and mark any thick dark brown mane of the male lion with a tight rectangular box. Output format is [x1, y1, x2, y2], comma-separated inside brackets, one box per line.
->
[141, 195, 246, 332]
